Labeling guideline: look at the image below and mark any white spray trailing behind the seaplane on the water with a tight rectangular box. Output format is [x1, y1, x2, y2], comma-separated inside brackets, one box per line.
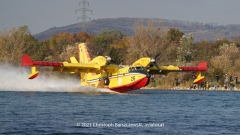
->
[0, 63, 114, 93]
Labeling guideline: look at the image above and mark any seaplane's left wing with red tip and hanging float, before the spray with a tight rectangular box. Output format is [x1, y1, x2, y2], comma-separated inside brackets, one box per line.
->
[22, 54, 103, 79]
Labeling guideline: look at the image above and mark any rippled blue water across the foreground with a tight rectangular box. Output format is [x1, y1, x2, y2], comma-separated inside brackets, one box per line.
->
[0, 90, 240, 135]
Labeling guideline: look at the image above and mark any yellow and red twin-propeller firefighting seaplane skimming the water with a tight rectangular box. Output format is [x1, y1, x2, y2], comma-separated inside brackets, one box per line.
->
[22, 43, 207, 93]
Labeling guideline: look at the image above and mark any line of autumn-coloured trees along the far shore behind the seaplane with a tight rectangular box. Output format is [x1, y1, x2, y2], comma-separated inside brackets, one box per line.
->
[0, 20, 240, 85]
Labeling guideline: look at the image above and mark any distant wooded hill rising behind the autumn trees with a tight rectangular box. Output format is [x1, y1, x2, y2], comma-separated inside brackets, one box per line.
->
[34, 18, 240, 42]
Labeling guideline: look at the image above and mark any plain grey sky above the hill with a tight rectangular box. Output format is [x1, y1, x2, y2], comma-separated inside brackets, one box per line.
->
[0, 0, 240, 34]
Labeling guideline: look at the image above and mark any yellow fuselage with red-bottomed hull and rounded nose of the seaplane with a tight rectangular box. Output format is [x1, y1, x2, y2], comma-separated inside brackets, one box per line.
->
[83, 66, 150, 93]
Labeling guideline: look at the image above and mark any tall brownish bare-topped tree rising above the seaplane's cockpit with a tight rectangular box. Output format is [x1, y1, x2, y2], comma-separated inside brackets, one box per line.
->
[127, 20, 165, 64]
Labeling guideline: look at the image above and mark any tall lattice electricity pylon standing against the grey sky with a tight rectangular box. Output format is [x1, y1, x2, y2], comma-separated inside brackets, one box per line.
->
[75, 0, 92, 31]
